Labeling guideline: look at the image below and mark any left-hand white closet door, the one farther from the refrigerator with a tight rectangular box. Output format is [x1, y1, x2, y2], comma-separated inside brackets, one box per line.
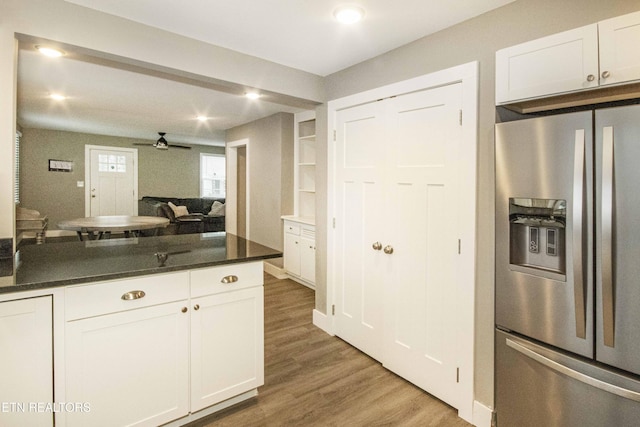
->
[335, 102, 384, 360]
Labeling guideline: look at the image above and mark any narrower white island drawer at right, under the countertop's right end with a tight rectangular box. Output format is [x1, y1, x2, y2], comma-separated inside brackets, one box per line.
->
[191, 261, 264, 298]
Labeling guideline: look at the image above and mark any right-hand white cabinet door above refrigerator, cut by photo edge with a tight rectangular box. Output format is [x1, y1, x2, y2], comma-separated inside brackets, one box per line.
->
[598, 12, 640, 84]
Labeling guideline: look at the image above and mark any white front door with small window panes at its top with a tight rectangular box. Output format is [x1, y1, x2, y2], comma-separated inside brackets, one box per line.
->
[85, 146, 138, 216]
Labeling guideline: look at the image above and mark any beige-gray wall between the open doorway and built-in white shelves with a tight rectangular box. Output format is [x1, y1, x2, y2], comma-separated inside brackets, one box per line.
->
[226, 113, 293, 250]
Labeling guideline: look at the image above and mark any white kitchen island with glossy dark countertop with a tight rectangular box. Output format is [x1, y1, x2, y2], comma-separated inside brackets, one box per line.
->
[0, 233, 281, 426]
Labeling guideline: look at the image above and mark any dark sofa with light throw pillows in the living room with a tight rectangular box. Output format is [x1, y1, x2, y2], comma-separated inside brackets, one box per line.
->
[138, 196, 225, 235]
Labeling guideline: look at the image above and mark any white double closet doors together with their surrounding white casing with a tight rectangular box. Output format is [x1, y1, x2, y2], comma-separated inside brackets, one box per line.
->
[327, 62, 478, 422]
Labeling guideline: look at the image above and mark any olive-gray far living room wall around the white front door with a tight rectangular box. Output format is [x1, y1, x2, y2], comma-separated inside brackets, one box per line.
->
[20, 129, 224, 230]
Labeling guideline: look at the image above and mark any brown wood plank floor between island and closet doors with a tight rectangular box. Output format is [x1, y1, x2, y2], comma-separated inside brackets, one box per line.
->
[189, 275, 471, 427]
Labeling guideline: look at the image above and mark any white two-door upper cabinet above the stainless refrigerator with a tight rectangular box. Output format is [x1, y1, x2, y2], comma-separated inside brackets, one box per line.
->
[496, 12, 640, 104]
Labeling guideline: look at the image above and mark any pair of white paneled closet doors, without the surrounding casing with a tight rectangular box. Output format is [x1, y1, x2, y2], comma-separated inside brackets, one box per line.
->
[335, 84, 462, 406]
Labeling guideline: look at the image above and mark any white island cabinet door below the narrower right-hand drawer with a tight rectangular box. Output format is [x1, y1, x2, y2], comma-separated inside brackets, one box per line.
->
[191, 286, 264, 412]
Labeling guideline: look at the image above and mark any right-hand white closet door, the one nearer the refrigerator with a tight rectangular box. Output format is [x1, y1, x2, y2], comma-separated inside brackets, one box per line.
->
[384, 84, 462, 407]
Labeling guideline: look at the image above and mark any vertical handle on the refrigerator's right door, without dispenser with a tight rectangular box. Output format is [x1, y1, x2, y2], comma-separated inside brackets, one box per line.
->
[600, 126, 615, 347]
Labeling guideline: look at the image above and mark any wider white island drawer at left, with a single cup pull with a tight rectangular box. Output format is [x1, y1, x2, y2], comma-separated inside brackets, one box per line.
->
[65, 271, 189, 321]
